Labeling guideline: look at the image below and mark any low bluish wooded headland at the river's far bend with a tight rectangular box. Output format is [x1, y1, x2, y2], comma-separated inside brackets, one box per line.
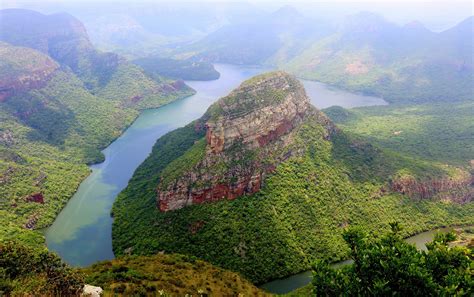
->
[133, 57, 220, 80]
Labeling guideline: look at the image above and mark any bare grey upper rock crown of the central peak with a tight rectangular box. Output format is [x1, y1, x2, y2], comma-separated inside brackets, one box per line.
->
[206, 72, 310, 153]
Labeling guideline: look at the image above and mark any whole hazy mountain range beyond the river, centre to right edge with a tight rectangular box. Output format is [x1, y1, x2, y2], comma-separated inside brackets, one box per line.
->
[175, 7, 474, 103]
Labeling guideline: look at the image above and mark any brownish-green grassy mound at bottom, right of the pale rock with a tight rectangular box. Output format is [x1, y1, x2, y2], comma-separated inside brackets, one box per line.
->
[82, 254, 269, 296]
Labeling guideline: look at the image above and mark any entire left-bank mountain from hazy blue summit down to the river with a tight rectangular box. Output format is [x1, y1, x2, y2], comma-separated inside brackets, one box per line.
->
[0, 10, 192, 243]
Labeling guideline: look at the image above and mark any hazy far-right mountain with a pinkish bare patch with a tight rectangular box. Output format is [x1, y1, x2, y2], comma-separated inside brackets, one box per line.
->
[284, 13, 473, 103]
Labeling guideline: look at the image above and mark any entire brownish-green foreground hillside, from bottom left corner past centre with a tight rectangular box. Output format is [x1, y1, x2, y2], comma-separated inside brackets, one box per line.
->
[0, 242, 270, 296]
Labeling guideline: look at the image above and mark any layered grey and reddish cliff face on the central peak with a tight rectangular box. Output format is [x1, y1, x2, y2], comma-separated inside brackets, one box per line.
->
[157, 72, 333, 211]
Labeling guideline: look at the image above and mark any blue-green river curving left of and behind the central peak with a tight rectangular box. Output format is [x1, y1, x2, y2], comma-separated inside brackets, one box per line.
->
[45, 64, 386, 266]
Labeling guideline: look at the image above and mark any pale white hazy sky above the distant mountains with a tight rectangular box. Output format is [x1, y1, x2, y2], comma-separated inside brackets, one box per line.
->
[0, 0, 474, 31]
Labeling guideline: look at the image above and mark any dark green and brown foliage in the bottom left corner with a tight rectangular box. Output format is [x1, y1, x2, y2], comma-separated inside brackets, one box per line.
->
[0, 242, 84, 296]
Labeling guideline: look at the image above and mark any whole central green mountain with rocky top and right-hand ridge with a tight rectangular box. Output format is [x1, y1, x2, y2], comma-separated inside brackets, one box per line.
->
[112, 72, 473, 283]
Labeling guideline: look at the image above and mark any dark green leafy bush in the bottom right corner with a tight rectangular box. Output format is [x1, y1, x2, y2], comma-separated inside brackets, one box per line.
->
[312, 223, 474, 296]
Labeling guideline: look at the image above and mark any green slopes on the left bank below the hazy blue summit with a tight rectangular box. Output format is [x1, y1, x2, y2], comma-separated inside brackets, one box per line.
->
[0, 43, 192, 245]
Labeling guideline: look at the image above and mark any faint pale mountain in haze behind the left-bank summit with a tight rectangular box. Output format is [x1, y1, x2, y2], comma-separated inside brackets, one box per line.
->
[21, 1, 264, 59]
